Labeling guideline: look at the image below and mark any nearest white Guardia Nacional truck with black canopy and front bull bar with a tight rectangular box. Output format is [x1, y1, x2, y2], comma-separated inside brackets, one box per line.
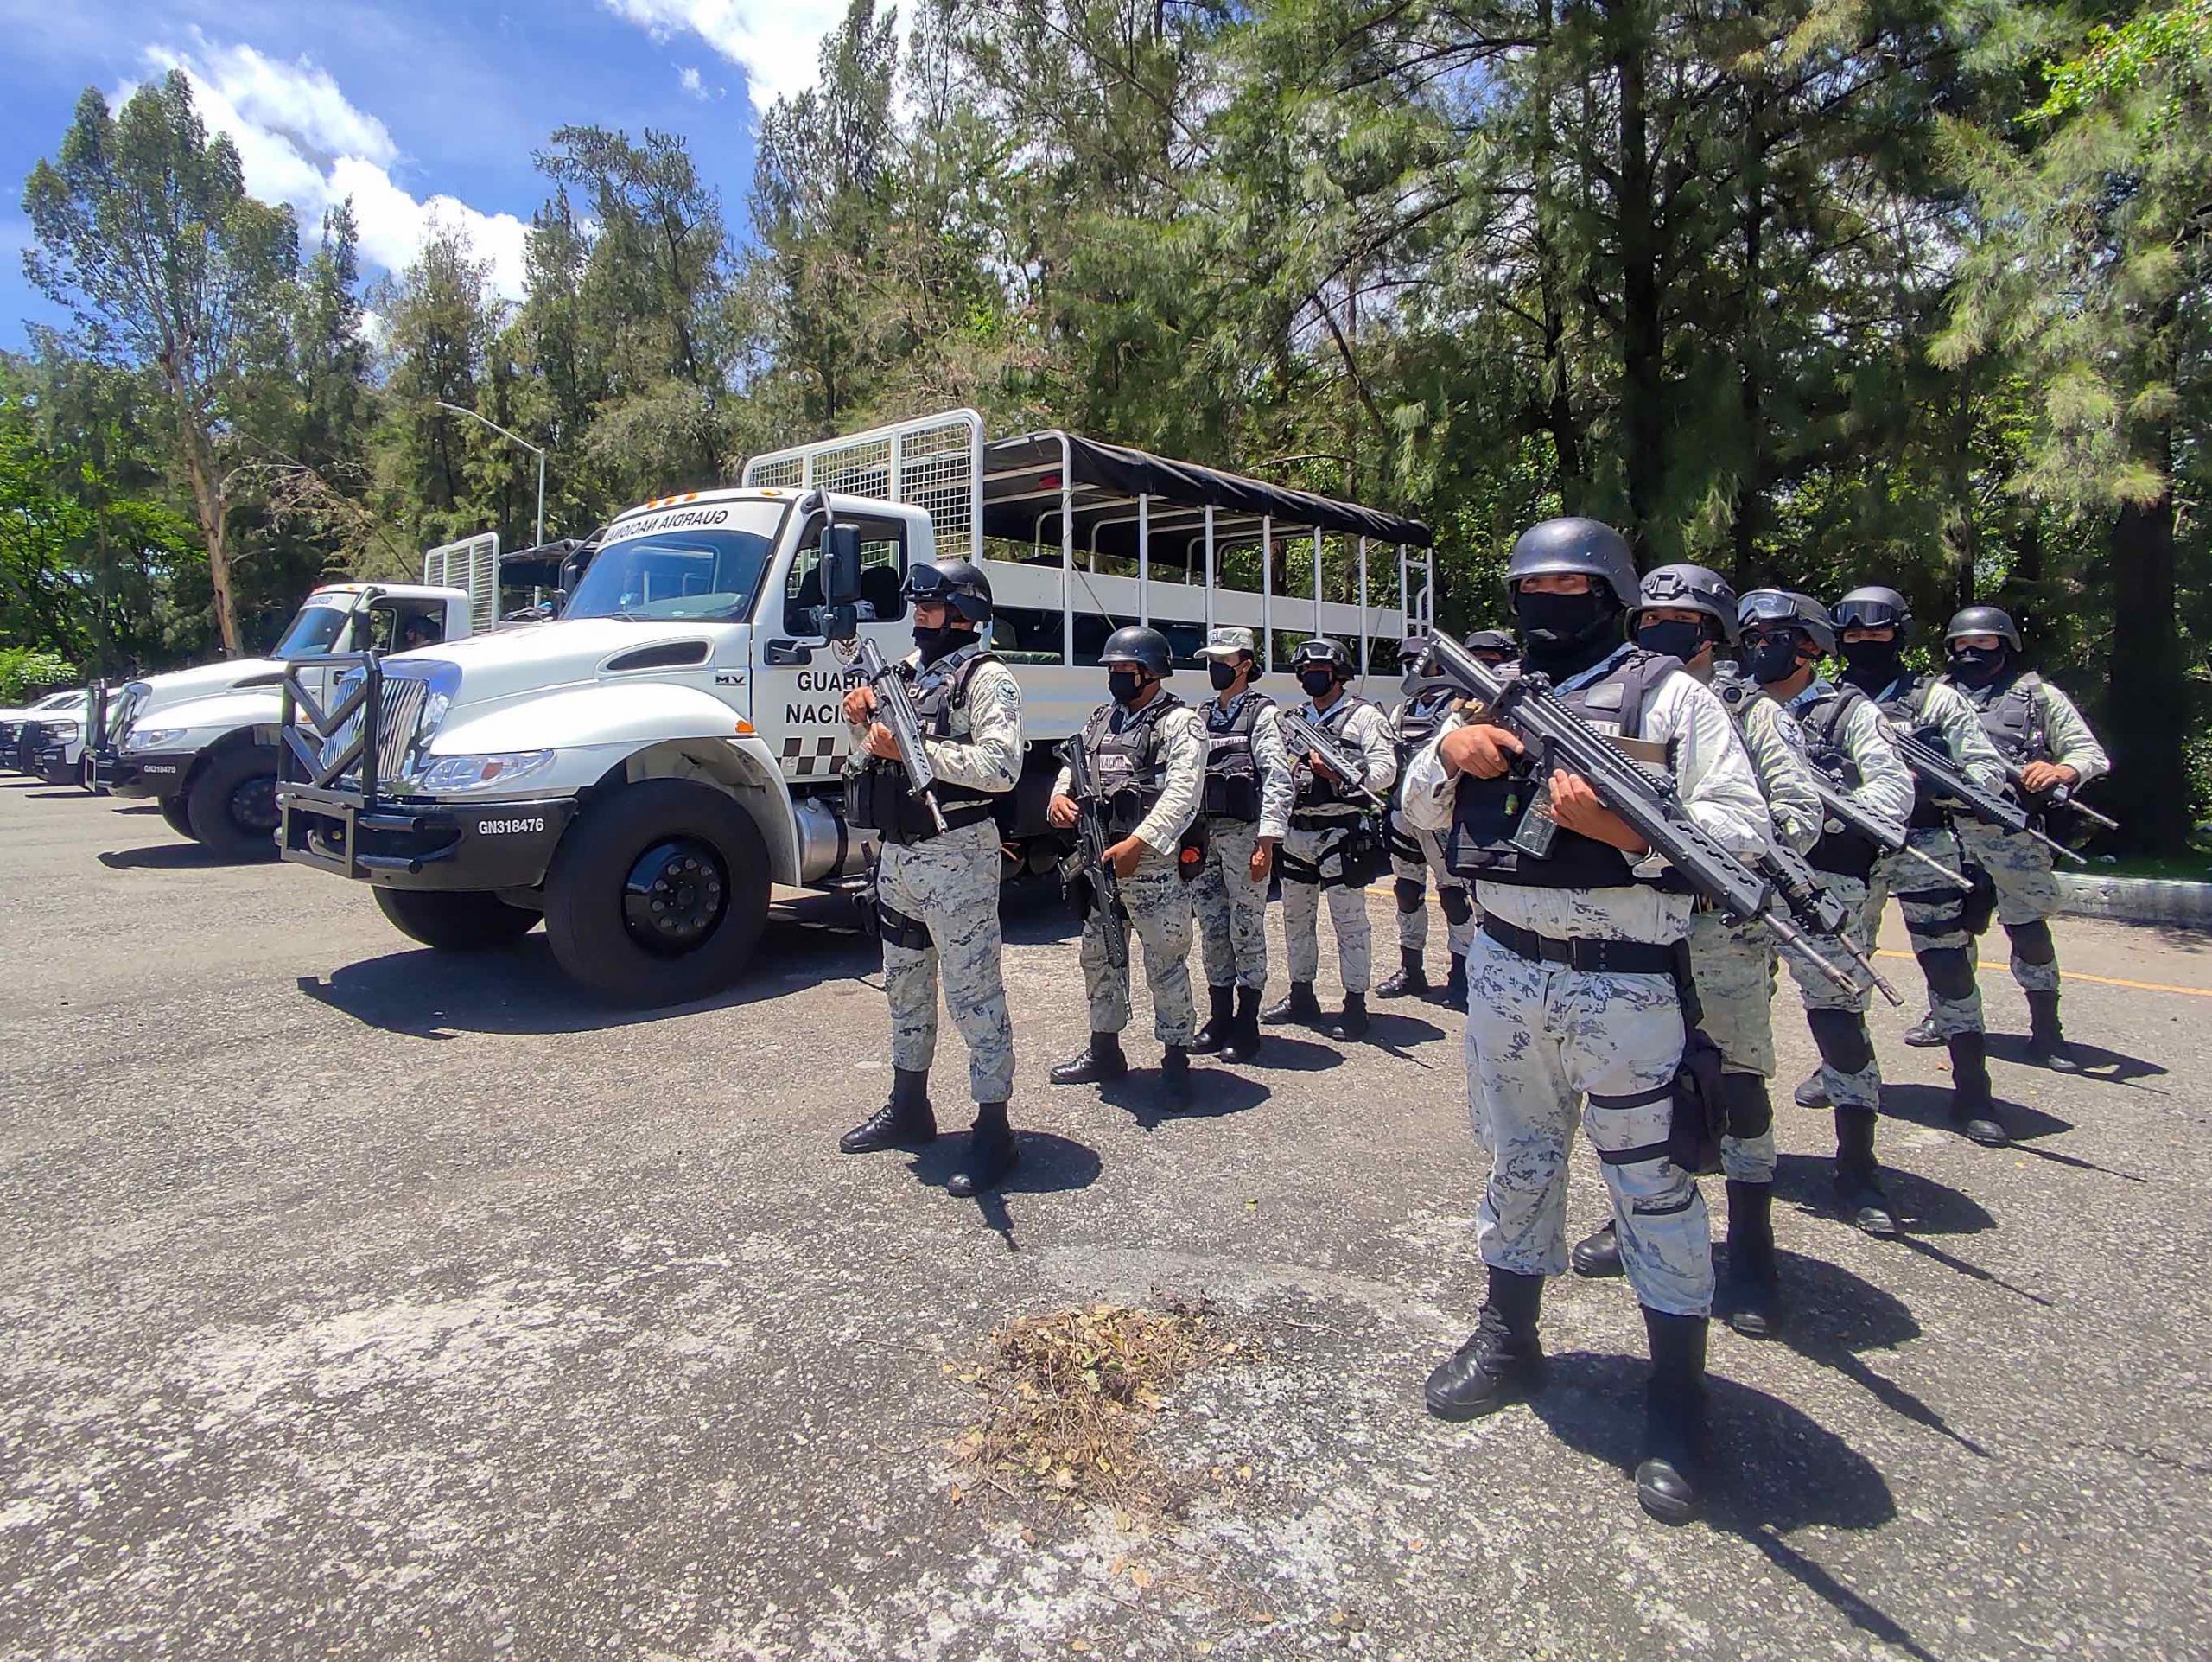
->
[276, 410, 1433, 1005]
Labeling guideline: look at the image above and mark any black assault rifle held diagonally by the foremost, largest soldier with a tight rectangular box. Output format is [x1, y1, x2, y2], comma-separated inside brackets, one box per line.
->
[1427, 635, 1858, 991]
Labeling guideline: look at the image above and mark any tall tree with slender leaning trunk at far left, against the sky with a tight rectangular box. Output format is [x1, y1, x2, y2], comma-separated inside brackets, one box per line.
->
[22, 71, 299, 653]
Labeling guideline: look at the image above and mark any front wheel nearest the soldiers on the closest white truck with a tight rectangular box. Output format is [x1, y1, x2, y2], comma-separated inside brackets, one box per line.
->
[546, 779, 767, 1005]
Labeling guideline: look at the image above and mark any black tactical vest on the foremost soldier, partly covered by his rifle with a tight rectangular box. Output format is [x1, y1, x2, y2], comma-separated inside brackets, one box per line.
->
[1445, 646, 1688, 892]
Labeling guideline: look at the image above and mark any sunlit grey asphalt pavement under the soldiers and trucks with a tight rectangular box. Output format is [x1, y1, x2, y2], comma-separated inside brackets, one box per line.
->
[0, 779, 2212, 1662]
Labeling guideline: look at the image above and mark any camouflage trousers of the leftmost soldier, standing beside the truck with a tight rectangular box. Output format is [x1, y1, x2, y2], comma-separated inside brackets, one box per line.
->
[876, 818, 1013, 1102]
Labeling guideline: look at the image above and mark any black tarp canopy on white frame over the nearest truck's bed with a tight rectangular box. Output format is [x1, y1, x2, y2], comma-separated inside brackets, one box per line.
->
[982, 430, 1433, 564]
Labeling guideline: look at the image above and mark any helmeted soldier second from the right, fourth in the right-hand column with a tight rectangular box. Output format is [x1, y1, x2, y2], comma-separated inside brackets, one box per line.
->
[1798, 587, 2008, 1146]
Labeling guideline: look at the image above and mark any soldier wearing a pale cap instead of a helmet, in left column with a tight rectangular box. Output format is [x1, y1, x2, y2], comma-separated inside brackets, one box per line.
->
[1190, 628, 1292, 1062]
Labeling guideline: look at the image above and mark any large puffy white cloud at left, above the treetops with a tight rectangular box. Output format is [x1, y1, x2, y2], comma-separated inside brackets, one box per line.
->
[135, 33, 526, 301]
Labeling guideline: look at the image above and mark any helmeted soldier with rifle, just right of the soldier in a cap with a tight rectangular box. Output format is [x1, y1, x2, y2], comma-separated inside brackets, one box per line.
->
[1261, 635, 1398, 1042]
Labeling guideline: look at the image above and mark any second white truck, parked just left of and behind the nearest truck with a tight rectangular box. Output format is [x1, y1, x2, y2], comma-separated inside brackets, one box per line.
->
[86, 533, 500, 859]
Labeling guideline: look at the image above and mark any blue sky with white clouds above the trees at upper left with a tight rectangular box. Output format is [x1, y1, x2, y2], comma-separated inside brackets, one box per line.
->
[0, 0, 842, 347]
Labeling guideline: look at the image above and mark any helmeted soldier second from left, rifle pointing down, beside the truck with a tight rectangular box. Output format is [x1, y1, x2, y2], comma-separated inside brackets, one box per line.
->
[1048, 628, 1205, 1109]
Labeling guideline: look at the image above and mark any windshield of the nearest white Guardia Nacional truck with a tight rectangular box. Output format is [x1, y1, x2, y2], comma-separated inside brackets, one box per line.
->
[562, 502, 783, 617]
